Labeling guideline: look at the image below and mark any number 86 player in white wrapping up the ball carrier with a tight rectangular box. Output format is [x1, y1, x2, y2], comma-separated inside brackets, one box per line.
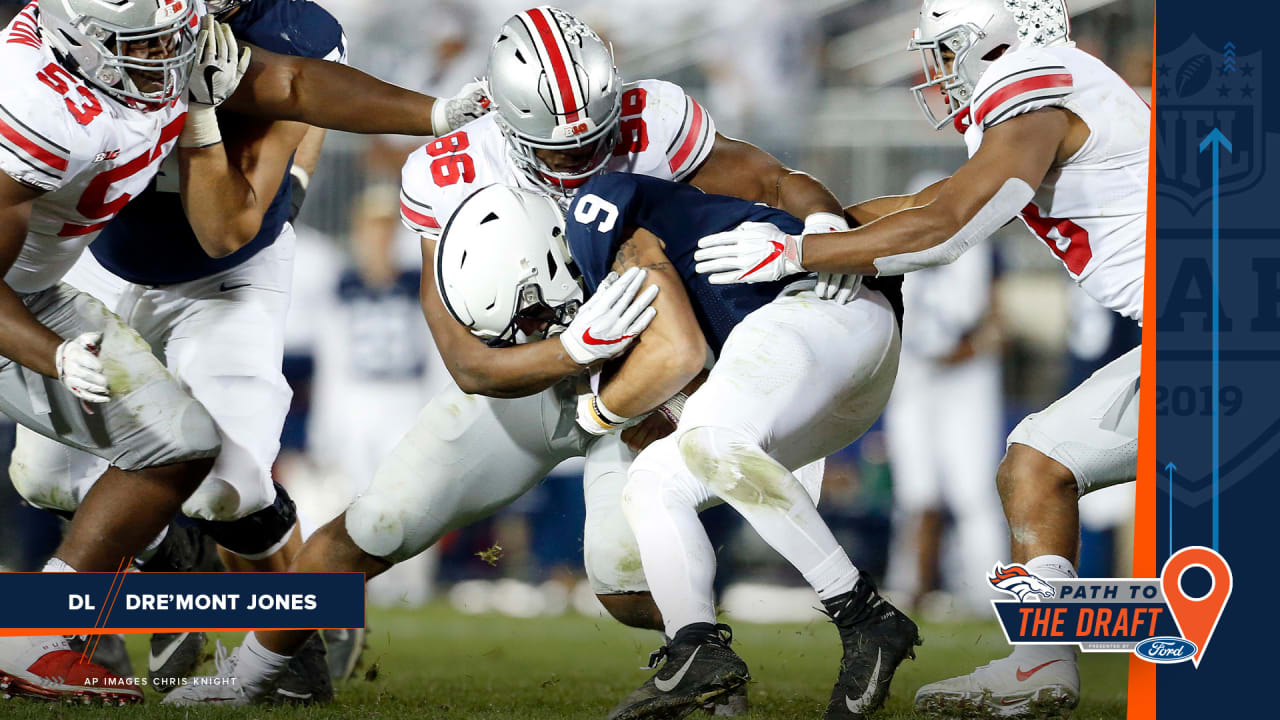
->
[166, 6, 856, 702]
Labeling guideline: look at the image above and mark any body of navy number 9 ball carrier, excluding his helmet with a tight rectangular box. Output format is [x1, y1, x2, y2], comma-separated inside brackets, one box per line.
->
[550, 174, 919, 720]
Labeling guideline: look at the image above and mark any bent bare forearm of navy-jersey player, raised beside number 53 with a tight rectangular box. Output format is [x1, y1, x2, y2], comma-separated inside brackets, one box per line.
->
[178, 143, 269, 258]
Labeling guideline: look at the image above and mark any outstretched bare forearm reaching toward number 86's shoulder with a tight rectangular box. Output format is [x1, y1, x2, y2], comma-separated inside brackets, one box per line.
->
[228, 49, 435, 136]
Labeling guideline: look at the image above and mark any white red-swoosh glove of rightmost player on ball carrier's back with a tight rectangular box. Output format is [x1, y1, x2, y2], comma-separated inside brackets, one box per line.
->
[694, 223, 805, 284]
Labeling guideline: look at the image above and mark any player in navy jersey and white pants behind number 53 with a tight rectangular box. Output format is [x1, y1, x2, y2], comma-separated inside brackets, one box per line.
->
[10, 0, 483, 701]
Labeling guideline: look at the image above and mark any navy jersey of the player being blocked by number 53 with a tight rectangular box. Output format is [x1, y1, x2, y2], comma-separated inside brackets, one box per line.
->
[90, 0, 347, 284]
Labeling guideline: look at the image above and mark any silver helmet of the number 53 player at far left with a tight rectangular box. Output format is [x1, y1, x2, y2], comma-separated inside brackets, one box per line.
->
[40, 0, 200, 104]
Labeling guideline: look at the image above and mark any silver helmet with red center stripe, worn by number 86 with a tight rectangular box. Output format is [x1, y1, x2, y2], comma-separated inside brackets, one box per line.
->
[488, 5, 622, 193]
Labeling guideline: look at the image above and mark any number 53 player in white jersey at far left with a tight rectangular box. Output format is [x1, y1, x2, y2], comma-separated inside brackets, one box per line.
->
[0, 0, 220, 702]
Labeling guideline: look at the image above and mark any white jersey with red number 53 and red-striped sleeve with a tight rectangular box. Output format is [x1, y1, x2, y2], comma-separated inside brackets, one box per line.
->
[0, 3, 187, 293]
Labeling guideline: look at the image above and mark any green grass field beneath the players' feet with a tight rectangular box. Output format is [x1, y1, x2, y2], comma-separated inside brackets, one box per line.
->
[0, 606, 1128, 720]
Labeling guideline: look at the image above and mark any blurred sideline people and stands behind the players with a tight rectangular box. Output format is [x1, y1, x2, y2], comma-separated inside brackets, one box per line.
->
[0, 0, 1153, 620]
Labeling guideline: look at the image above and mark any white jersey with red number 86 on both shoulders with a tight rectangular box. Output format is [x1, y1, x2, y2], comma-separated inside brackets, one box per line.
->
[401, 79, 716, 237]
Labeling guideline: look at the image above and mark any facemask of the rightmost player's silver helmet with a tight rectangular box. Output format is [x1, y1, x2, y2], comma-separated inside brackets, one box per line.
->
[908, 24, 989, 129]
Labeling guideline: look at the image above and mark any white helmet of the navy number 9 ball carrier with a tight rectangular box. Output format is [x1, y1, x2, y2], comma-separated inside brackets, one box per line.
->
[435, 184, 582, 345]
